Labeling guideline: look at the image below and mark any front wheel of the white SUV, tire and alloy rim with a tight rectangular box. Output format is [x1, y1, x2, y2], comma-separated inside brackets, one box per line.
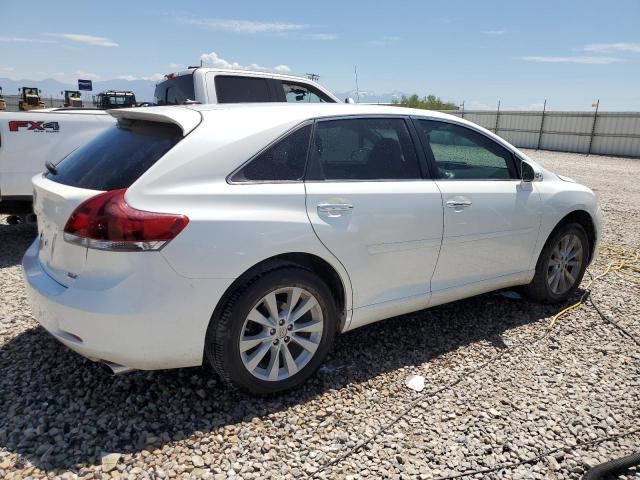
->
[524, 223, 590, 304]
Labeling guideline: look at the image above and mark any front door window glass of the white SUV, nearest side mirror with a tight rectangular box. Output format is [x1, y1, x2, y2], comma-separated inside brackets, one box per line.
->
[418, 120, 518, 180]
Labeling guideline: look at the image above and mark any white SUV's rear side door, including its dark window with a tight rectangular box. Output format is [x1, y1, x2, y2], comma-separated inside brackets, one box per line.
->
[305, 116, 442, 308]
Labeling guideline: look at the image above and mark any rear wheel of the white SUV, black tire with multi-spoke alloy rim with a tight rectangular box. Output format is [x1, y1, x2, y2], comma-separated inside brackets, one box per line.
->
[205, 265, 337, 396]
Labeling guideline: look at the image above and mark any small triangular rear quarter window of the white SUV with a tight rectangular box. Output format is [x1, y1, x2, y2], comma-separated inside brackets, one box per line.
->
[230, 124, 311, 183]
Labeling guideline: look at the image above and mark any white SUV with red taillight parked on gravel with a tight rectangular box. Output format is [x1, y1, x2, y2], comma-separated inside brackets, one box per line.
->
[23, 104, 600, 394]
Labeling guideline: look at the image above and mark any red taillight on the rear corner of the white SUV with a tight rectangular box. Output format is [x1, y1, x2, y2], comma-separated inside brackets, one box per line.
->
[64, 189, 189, 251]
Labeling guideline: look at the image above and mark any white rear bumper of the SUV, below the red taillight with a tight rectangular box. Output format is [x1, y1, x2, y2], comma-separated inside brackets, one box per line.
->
[22, 240, 232, 370]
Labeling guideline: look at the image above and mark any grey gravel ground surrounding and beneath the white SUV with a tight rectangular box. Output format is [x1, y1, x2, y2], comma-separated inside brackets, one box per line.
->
[0, 151, 640, 479]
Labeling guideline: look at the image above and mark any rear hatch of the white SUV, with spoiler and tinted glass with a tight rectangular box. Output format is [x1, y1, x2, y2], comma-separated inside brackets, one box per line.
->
[33, 109, 200, 286]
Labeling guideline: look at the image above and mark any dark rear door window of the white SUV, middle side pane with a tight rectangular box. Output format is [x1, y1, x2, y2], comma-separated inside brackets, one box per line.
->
[306, 118, 421, 180]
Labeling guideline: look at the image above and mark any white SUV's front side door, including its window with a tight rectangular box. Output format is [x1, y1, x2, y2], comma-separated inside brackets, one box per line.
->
[415, 119, 541, 293]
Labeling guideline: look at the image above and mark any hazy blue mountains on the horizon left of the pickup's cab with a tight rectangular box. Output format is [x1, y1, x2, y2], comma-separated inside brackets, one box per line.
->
[0, 78, 155, 102]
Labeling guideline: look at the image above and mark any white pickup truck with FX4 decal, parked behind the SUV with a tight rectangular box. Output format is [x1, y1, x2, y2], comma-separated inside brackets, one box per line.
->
[0, 67, 340, 219]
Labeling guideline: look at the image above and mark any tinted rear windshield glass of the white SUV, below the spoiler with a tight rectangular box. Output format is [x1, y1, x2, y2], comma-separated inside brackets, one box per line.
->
[46, 120, 182, 190]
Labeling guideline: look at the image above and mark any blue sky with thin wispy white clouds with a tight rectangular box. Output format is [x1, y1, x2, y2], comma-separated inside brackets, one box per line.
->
[0, 0, 640, 110]
